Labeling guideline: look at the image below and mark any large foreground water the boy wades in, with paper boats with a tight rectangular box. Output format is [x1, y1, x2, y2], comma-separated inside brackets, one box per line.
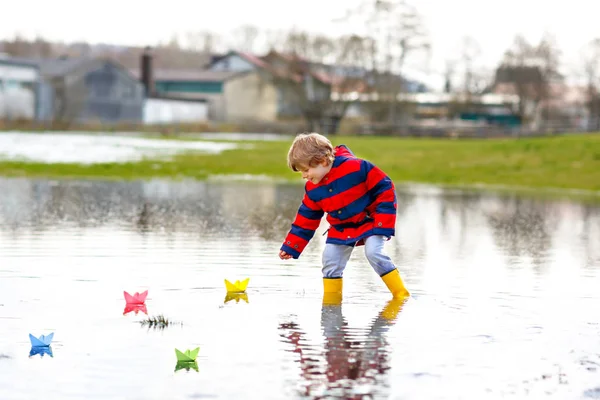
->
[0, 179, 600, 400]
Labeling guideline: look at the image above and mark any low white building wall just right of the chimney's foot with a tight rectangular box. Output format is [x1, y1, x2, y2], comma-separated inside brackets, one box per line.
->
[144, 98, 208, 124]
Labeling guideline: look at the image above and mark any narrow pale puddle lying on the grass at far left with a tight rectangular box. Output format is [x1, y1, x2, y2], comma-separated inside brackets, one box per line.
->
[0, 132, 236, 164]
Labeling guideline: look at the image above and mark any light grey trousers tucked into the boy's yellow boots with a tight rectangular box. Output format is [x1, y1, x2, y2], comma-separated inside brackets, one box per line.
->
[323, 235, 396, 278]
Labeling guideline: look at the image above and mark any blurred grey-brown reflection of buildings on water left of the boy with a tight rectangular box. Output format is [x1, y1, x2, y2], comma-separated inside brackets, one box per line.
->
[0, 178, 298, 239]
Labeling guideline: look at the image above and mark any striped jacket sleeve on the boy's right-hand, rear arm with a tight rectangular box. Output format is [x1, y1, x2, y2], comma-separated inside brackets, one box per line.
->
[363, 160, 397, 237]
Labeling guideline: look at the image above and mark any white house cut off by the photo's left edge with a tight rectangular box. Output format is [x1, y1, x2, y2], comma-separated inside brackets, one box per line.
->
[0, 53, 40, 120]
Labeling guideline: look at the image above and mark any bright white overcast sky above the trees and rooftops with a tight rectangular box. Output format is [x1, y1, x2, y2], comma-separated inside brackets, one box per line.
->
[0, 0, 600, 89]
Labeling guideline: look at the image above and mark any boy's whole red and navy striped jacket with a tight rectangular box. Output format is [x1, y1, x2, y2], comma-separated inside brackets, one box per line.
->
[281, 145, 397, 258]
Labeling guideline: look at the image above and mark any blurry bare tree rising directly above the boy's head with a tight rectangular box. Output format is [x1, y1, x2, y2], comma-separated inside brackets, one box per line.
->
[264, 31, 370, 134]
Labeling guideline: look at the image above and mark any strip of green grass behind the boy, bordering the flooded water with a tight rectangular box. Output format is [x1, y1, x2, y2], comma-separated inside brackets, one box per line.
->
[0, 134, 600, 191]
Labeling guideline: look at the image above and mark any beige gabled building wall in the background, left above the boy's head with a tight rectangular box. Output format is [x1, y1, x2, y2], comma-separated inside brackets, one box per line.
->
[224, 72, 278, 122]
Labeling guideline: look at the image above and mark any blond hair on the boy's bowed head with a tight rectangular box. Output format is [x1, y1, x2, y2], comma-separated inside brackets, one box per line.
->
[288, 133, 335, 172]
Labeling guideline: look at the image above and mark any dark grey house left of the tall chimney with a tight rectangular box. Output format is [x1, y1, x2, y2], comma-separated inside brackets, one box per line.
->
[38, 58, 145, 123]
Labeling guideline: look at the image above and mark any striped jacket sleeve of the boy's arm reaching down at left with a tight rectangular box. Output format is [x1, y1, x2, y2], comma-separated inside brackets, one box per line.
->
[281, 193, 325, 258]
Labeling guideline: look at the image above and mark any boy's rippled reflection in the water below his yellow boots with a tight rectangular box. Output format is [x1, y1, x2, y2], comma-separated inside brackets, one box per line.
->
[279, 298, 406, 399]
